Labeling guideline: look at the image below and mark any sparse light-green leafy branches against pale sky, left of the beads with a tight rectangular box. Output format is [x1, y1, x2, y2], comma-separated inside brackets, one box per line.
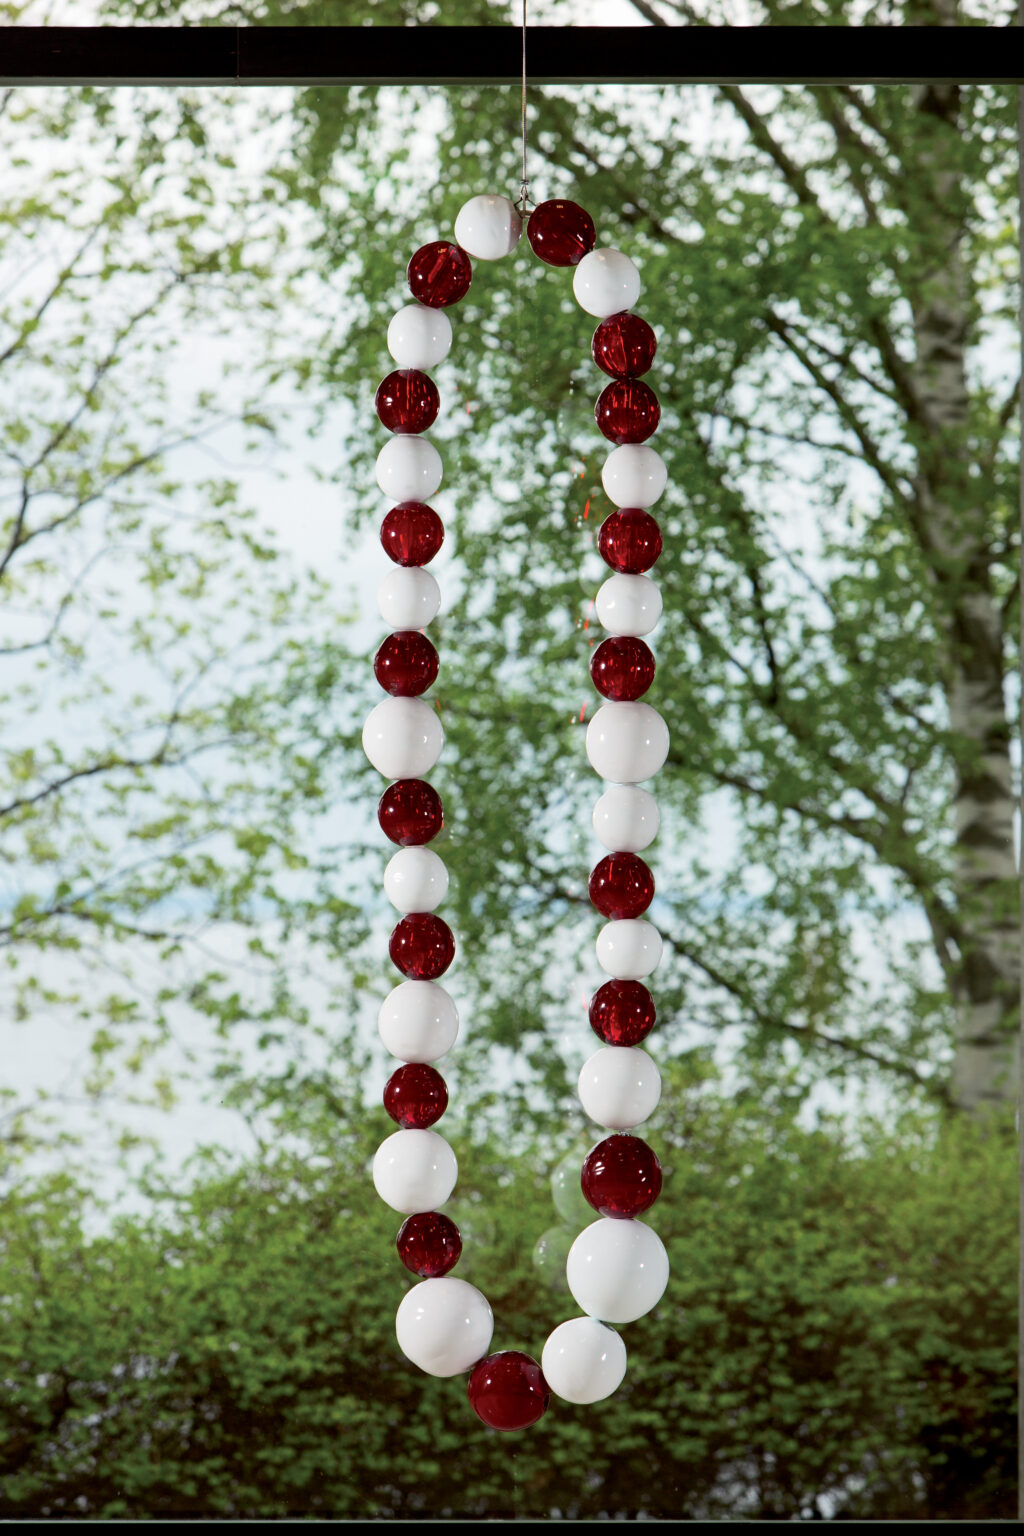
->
[0, 72, 373, 1146]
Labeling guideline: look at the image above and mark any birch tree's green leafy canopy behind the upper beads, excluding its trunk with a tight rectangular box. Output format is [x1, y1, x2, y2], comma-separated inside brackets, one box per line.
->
[92, 0, 1018, 1098]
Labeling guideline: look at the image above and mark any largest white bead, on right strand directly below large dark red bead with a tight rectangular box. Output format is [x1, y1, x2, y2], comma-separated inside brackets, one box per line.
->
[565, 1217, 668, 1322]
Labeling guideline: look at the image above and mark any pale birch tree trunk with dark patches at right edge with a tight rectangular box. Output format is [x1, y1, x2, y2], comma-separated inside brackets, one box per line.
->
[907, 0, 1021, 1112]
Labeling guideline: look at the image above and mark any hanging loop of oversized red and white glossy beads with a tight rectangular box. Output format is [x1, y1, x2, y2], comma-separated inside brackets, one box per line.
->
[362, 197, 668, 1430]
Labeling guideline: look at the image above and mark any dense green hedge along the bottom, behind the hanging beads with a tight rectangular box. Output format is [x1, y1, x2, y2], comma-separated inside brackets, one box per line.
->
[0, 1060, 1016, 1519]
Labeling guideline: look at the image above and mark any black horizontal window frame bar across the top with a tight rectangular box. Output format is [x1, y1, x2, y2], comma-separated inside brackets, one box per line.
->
[0, 26, 1024, 86]
